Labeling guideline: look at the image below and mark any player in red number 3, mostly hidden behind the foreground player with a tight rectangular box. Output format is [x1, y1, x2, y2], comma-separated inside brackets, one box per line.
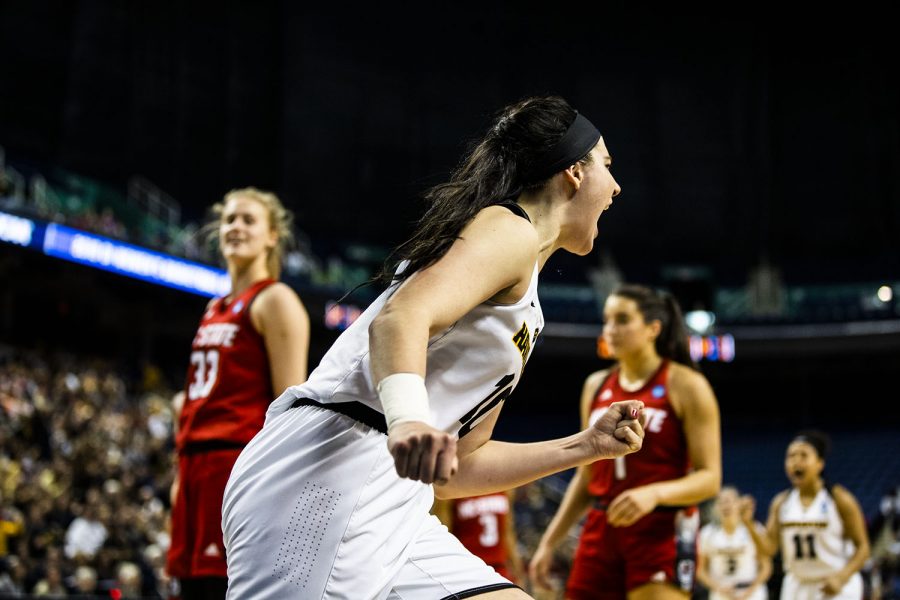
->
[431, 490, 525, 586]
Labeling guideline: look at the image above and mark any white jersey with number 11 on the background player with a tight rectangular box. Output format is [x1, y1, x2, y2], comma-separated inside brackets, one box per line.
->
[778, 488, 855, 579]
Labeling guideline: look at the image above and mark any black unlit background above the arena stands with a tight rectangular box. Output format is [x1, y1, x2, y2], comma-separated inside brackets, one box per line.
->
[0, 0, 900, 284]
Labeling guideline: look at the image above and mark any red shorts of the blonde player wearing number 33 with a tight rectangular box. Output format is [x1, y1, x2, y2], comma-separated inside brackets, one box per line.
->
[166, 448, 241, 579]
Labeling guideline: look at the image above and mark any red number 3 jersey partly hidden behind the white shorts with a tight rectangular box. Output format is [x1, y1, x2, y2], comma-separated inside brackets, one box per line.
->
[453, 492, 511, 568]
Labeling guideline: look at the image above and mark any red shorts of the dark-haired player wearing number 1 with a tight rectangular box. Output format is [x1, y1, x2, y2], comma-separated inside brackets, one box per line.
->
[566, 509, 696, 600]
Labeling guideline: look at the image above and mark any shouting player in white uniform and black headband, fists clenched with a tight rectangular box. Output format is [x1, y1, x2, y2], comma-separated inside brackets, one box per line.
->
[222, 97, 643, 600]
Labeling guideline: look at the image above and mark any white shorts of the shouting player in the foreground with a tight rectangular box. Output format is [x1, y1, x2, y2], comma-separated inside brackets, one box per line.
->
[222, 406, 515, 600]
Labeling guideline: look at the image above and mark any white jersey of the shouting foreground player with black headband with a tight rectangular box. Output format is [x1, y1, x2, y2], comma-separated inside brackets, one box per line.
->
[278, 263, 544, 437]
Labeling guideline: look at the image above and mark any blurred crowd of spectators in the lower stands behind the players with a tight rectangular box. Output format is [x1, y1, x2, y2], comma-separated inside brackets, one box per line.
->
[0, 347, 900, 599]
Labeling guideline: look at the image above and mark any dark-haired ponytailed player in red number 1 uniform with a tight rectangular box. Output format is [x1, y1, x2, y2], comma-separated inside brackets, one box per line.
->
[530, 285, 722, 600]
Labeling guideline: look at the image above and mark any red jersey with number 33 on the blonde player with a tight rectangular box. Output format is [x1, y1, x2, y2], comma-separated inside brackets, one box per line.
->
[176, 279, 275, 451]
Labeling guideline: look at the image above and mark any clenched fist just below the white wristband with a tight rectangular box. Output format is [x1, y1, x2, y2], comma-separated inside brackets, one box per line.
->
[388, 421, 459, 485]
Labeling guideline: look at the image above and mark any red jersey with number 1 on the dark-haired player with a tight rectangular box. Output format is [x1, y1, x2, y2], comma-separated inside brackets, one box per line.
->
[588, 360, 690, 505]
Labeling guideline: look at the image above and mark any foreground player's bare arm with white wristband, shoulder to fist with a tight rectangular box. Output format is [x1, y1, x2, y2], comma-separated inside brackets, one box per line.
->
[369, 206, 538, 483]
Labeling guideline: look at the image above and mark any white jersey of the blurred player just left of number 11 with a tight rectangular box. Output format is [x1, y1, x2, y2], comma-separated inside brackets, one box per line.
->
[699, 523, 758, 586]
